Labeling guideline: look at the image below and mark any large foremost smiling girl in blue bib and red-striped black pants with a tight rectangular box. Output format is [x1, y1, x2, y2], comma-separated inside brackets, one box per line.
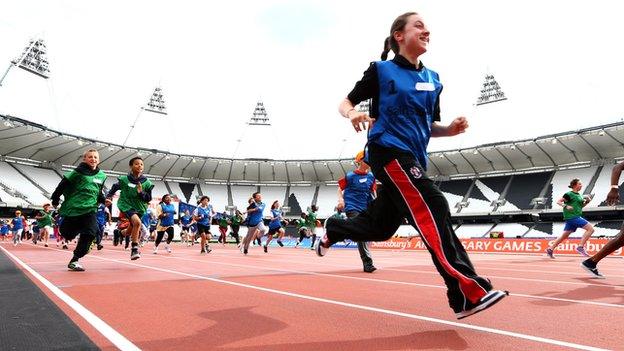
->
[315, 12, 507, 319]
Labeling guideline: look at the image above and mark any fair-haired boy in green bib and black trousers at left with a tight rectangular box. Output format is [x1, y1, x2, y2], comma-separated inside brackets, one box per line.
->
[52, 149, 106, 272]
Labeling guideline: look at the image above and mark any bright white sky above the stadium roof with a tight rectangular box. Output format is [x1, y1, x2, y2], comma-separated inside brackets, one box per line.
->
[0, 0, 624, 159]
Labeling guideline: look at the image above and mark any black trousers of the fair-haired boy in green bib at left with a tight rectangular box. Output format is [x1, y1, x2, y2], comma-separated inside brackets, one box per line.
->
[59, 212, 99, 261]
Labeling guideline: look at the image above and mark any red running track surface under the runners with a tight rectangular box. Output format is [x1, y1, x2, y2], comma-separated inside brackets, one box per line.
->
[2, 243, 624, 351]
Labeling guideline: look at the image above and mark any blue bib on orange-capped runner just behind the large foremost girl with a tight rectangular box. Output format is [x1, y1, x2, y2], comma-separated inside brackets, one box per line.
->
[339, 172, 375, 212]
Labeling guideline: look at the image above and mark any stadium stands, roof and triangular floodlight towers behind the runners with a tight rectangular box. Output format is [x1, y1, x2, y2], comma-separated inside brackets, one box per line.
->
[0, 39, 624, 242]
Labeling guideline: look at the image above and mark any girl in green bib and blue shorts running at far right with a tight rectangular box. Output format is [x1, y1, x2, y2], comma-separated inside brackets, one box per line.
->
[546, 178, 594, 258]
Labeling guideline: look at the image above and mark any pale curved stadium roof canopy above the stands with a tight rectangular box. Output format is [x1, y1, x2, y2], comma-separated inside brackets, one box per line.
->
[0, 115, 624, 184]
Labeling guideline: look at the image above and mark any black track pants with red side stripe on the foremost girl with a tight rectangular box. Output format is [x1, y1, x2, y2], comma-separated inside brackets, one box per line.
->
[326, 144, 492, 312]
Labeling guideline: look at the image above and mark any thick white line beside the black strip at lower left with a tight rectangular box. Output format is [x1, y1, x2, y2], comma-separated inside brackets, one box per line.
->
[0, 246, 140, 351]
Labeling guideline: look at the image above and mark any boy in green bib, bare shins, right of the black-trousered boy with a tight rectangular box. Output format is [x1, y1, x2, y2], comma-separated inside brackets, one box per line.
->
[107, 156, 154, 260]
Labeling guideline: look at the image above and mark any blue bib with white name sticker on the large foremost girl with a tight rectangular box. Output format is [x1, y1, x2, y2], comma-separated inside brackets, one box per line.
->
[368, 61, 442, 170]
